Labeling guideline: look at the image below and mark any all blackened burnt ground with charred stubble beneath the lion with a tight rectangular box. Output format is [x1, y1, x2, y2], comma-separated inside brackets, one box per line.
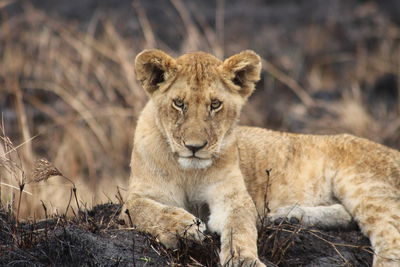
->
[0, 204, 372, 266]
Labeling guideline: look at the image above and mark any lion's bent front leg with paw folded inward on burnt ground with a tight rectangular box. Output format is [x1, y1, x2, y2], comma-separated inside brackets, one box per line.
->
[120, 195, 206, 248]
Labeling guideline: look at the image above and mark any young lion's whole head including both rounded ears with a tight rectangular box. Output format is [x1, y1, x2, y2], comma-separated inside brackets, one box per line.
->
[136, 50, 260, 169]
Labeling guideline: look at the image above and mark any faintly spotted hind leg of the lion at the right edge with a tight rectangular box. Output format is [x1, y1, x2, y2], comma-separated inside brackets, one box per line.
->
[334, 171, 400, 267]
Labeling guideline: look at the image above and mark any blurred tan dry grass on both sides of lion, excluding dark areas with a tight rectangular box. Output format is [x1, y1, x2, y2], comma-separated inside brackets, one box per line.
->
[0, 0, 400, 220]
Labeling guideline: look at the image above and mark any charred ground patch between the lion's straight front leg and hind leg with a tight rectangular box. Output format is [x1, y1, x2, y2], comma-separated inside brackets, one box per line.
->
[259, 224, 372, 266]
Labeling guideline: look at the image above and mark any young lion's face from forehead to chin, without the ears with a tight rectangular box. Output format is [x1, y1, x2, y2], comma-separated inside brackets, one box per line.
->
[153, 73, 243, 168]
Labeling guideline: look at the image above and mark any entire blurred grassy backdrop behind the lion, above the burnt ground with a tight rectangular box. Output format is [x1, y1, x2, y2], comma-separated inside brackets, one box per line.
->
[0, 0, 400, 216]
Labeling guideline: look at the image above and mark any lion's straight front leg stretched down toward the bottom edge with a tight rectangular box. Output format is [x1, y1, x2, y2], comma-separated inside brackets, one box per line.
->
[203, 177, 265, 267]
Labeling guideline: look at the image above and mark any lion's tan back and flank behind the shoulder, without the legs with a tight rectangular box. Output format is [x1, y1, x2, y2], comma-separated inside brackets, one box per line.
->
[235, 126, 400, 208]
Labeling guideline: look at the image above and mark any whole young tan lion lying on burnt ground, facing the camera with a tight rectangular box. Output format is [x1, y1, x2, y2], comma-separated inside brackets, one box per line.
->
[122, 50, 400, 266]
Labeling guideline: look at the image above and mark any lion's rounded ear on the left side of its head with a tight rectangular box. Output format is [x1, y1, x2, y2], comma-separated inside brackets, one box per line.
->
[135, 49, 176, 95]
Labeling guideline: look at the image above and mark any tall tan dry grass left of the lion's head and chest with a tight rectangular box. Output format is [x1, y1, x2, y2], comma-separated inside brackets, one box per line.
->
[0, 0, 228, 219]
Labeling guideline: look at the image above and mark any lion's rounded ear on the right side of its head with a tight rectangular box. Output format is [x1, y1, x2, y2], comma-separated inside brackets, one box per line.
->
[222, 50, 261, 97]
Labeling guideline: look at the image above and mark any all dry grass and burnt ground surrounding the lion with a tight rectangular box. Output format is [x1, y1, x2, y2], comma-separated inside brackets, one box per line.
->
[0, 0, 400, 266]
